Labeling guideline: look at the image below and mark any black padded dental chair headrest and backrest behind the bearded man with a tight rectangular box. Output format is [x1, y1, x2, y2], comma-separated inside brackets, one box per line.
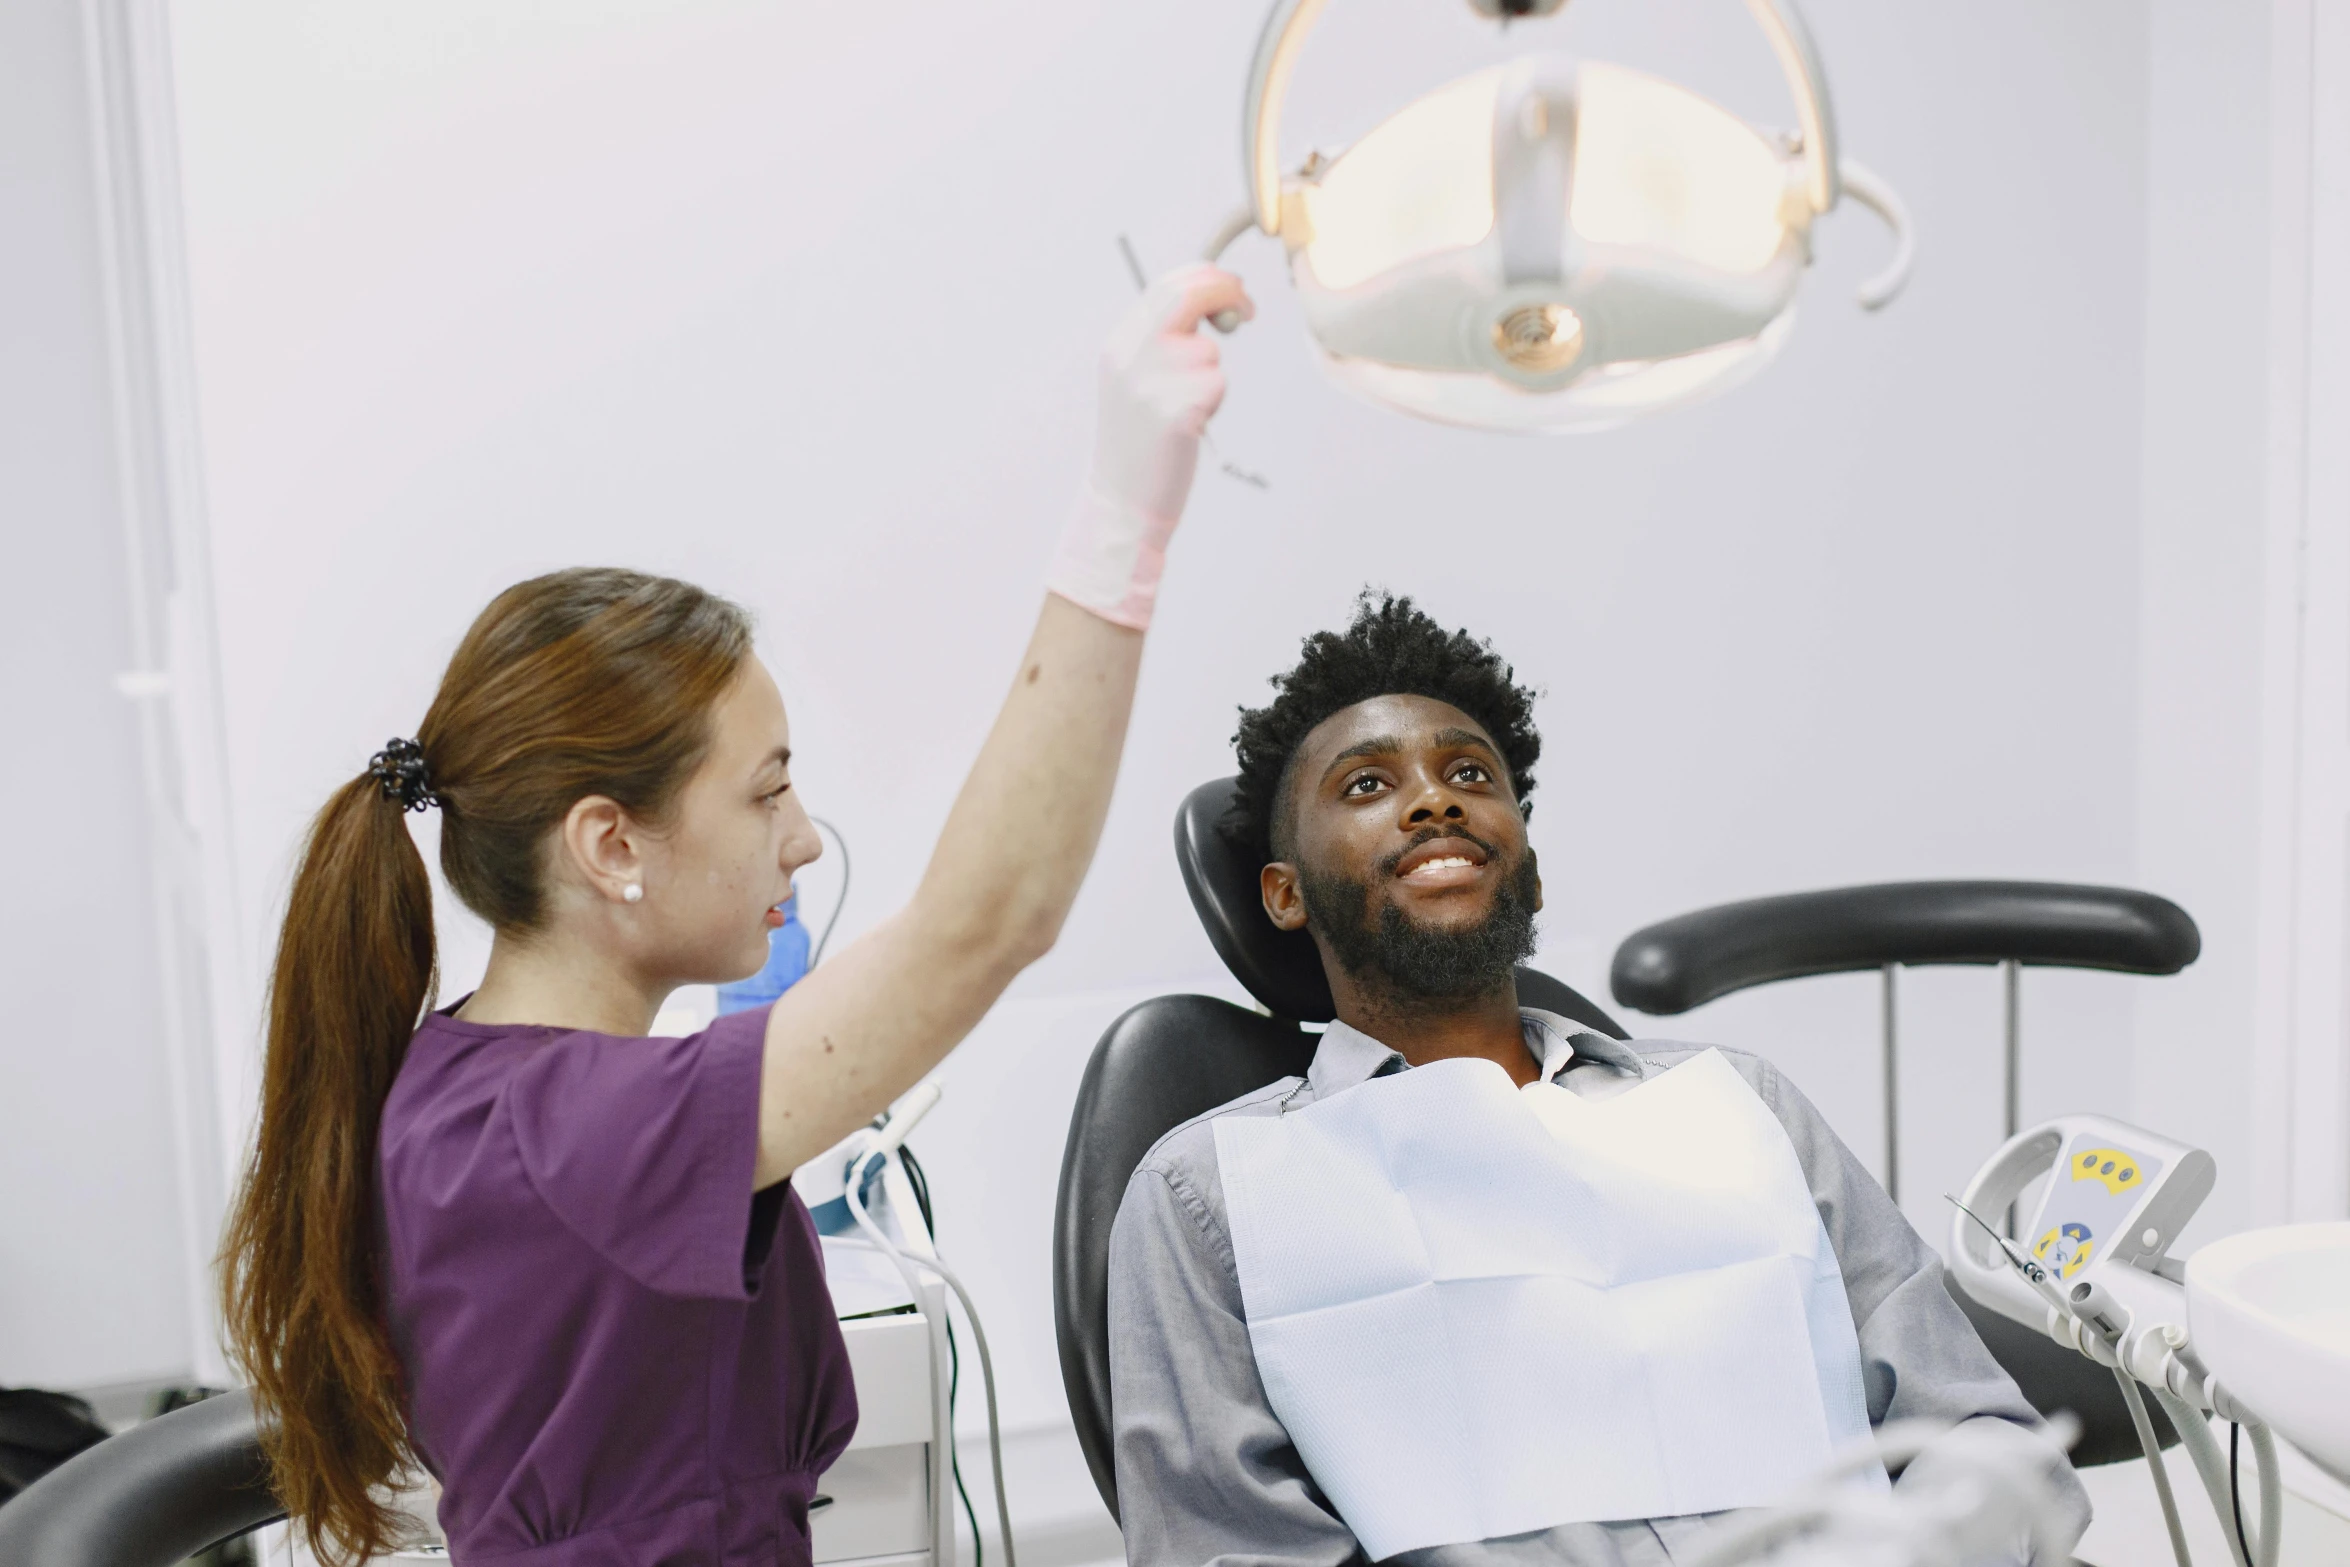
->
[1053, 778, 1629, 1513]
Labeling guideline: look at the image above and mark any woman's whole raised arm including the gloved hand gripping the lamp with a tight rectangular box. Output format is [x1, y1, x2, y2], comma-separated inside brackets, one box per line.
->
[757, 265, 1248, 1186]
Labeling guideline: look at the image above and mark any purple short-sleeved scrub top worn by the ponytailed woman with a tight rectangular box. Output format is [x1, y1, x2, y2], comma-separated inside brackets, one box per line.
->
[381, 1008, 858, 1567]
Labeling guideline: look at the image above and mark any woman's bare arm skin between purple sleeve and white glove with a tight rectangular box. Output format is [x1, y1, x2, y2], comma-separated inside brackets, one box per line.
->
[759, 597, 1142, 1186]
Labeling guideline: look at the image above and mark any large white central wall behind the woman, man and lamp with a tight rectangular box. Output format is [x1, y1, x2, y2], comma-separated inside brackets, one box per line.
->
[151, 0, 2162, 1456]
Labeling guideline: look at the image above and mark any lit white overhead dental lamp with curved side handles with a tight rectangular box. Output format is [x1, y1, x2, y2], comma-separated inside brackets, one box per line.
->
[1208, 0, 1913, 432]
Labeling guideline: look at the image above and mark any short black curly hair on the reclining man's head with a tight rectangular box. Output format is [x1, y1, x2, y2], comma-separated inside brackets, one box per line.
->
[1224, 587, 1542, 865]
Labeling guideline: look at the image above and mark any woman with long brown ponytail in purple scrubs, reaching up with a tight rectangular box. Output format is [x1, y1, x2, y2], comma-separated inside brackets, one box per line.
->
[223, 265, 1250, 1567]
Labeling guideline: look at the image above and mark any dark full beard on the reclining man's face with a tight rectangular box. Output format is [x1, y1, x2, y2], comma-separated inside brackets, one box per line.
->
[1297, 850, 1542, 1010]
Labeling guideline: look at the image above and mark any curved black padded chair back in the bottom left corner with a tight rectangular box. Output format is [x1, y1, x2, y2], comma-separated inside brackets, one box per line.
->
[0, 1393, 284, 1567]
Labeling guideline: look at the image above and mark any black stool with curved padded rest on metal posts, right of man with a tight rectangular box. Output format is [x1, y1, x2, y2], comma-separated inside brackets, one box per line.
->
[1607, 881, 2202, 1468]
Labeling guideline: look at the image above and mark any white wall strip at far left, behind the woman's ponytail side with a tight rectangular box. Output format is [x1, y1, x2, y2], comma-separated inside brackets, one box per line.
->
[0, 0, 193, 1386]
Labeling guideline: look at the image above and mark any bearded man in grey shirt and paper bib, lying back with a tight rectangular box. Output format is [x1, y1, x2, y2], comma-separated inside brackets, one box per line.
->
[1109, 592, 2089, 1567]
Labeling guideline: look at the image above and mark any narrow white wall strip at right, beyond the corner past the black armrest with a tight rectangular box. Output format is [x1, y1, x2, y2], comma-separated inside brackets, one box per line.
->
[2131, 0, 2270, 1236]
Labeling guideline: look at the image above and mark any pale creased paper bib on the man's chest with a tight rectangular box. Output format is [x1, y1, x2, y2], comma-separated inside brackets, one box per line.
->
[1215, 1050, 1882, 1560]
